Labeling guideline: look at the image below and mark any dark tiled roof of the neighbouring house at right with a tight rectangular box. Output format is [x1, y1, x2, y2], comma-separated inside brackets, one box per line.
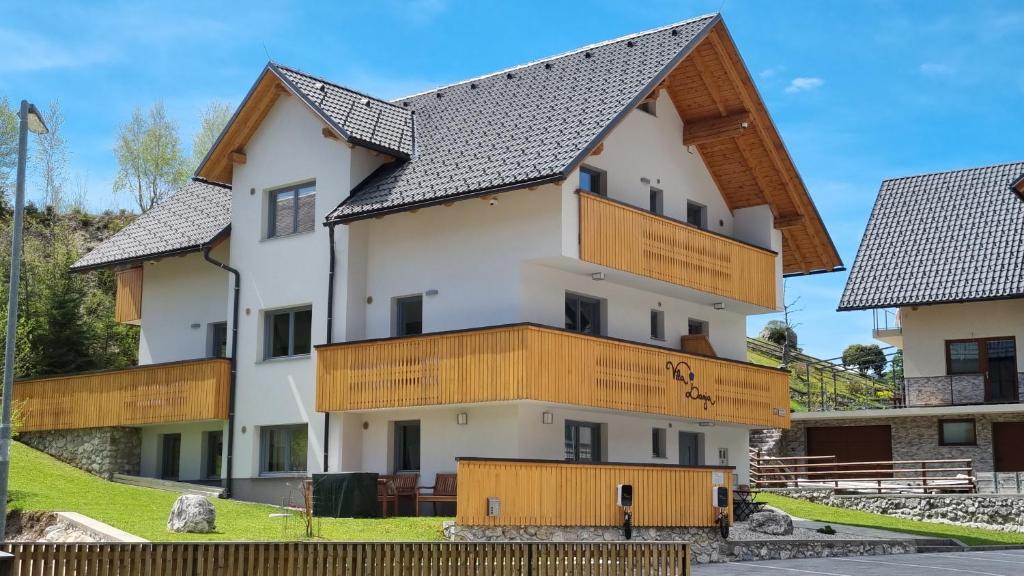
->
[839, 162, 1024, 310]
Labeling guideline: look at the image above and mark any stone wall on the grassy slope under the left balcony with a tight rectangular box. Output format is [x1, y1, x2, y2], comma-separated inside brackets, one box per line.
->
[17, 427, 142, 479]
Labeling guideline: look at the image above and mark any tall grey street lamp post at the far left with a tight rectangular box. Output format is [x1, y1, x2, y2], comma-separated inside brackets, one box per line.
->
[0, 100, 47, 540]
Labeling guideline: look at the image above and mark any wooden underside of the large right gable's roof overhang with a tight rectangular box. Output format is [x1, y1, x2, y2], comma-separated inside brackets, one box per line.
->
[660, 23, 842, 274]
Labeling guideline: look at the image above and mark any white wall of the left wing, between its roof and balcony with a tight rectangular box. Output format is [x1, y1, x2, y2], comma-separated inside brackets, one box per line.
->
[138, 242, 230, 364]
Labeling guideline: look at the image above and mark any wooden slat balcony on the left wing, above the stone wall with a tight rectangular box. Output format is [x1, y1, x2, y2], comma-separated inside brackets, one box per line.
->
[14, 359, 230, 431]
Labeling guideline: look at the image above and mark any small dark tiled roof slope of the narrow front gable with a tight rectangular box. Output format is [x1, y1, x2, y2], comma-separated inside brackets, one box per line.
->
[270, 64, 413, 158]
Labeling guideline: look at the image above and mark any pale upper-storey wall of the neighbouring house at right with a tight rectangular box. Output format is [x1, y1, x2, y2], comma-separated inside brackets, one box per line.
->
[900, 299, 1024, 377]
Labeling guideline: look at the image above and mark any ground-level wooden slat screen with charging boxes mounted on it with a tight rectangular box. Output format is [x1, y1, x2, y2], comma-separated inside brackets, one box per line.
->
[456, 459, 732, 527]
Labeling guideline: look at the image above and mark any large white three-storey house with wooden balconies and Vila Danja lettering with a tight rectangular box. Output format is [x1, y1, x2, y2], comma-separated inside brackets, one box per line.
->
[17, 10, 841, 524]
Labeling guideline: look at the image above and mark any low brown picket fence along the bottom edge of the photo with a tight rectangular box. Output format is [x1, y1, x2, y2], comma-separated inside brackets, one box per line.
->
[2, 542, 690, 576]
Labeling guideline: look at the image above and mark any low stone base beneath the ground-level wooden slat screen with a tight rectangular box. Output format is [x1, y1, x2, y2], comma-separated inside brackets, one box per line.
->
[443, 522, 726, 564]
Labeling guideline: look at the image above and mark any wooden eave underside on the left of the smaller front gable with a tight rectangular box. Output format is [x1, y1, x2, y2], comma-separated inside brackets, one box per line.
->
[197, 69, 290, 183]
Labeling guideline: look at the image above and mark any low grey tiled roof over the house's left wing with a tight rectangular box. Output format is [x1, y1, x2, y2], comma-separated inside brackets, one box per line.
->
[71, 180, 231, 271]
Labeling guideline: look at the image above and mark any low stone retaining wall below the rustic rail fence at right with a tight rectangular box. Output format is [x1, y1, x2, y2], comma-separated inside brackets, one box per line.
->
[785, 490, 1024, 532]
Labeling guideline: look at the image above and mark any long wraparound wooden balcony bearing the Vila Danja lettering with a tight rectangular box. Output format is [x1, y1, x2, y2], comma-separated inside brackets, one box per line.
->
[316, 324, 790, 427]
